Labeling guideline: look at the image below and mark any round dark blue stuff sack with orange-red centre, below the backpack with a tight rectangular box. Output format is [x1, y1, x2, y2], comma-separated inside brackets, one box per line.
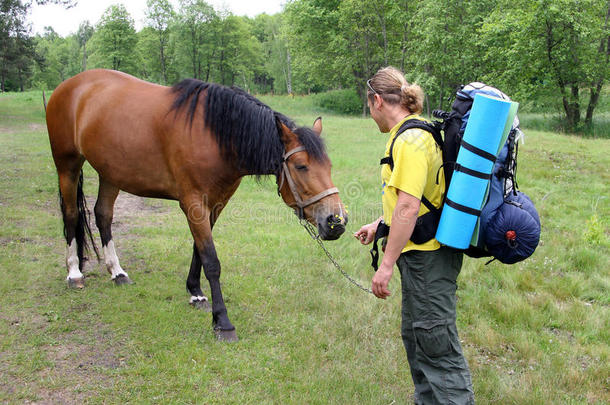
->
[482, 191, 540, 264]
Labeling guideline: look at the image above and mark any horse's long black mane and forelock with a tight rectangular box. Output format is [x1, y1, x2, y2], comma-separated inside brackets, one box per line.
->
[172, 79, 327, 175]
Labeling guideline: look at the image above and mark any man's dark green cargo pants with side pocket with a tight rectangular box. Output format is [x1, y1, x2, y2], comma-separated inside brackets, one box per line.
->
[397, 247, 474, 405]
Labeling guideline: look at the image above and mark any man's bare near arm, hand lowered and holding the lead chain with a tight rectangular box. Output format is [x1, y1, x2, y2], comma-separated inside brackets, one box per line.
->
[372, 190, 421, 299]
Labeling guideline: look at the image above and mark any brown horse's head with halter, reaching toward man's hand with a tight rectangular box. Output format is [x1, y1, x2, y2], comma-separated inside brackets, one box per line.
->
[278, 118, 347, 240]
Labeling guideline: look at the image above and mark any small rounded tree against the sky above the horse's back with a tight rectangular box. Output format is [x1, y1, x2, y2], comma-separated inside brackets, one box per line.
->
[94, 4, 137, 72]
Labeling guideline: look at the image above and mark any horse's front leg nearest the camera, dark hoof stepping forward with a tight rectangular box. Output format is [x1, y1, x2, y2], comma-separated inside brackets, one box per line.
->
[180, 199, 237, 342]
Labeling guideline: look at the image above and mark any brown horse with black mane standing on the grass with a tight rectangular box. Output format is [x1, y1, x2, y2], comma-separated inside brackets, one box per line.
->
[47, 70, 347, 340]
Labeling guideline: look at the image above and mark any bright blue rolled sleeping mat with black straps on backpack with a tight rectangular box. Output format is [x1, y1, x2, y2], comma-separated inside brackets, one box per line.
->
[436, 94, 512, 249]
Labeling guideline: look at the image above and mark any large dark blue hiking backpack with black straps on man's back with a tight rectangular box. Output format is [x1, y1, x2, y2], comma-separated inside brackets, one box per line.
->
[371, 82, 540, 270]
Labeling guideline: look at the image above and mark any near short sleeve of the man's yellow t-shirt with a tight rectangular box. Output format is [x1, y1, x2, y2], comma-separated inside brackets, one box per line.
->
[388, 133, 428, 200]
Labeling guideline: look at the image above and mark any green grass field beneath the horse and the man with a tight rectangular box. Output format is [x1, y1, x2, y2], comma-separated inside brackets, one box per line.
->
[0, 93, 610, 404]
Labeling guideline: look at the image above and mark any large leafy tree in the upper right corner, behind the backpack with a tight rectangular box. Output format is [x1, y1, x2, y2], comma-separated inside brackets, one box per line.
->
[481, 0, 610, 130]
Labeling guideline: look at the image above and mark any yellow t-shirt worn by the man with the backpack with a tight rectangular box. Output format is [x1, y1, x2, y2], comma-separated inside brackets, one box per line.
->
[381, 115, 445, 252]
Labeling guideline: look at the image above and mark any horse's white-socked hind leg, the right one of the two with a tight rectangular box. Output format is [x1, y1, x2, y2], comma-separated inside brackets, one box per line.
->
[94, 177, 132, 285]
